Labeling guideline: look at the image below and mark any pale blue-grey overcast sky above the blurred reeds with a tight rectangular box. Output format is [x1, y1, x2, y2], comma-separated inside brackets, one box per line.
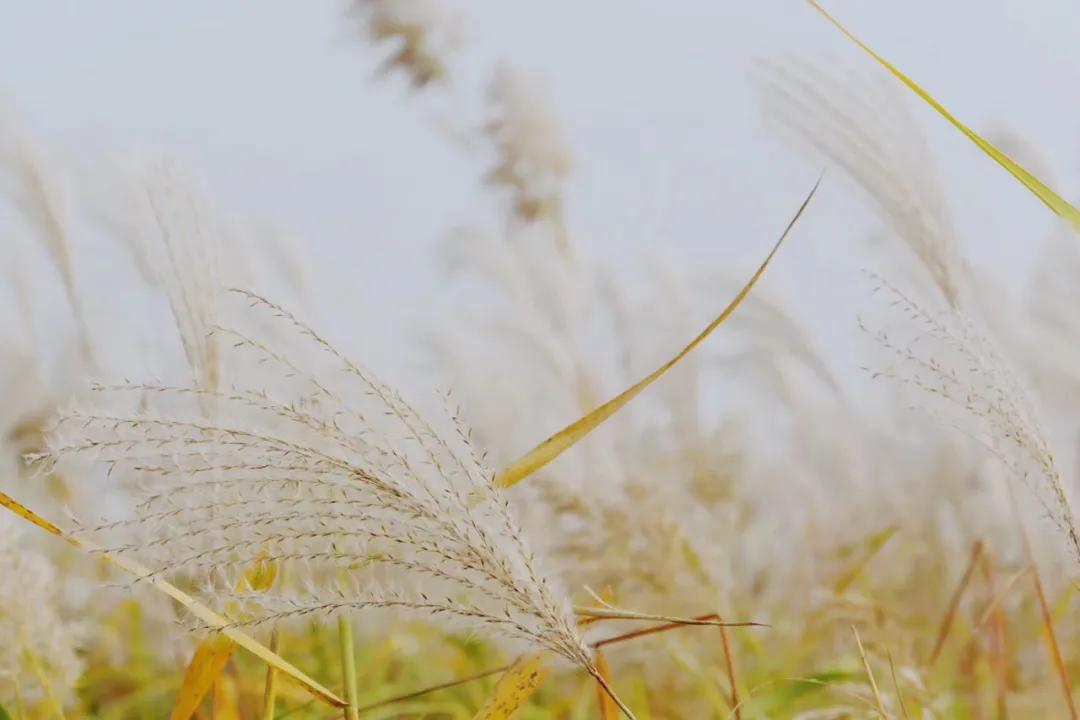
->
[0, 0, 1080, 388]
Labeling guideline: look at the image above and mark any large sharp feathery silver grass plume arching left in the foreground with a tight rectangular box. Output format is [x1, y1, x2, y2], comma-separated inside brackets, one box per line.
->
[35, 290, 594, 671]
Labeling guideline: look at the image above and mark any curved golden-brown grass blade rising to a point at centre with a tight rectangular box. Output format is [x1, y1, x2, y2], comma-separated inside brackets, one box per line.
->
[496, 177, 821, 488]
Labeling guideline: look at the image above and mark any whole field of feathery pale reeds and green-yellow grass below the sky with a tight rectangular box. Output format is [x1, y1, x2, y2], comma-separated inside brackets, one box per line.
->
[0, 0, 1080, 720]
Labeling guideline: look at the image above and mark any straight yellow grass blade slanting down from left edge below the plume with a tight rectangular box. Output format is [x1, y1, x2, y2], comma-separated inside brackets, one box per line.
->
[0, 492, 345, 707]
